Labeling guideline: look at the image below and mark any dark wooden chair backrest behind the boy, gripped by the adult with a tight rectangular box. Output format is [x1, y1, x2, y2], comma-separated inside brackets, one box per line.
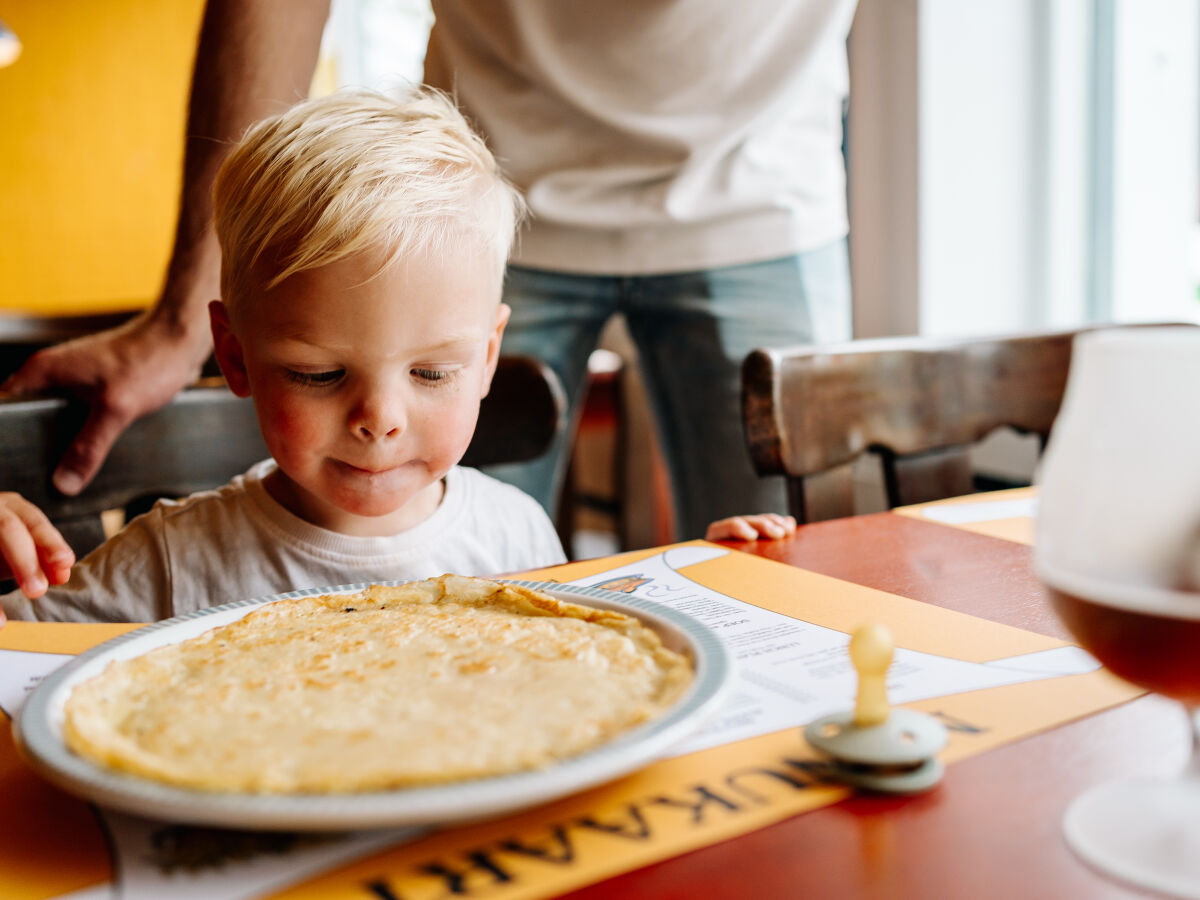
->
[0, 356, 566, 557]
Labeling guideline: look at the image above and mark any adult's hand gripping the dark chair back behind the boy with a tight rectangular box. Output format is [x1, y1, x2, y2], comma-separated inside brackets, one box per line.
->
[0, 313, 212, 494]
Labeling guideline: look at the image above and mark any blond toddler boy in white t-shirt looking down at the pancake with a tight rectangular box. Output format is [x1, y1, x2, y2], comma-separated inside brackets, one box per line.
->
[0, 91, 794, 622]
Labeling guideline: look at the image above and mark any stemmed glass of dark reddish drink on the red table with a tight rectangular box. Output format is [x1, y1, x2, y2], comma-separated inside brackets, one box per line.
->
[1034, 326, 1200, 898]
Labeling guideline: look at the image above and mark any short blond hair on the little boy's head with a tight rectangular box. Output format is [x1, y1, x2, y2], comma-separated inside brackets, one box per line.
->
[212, 89, 524, 306]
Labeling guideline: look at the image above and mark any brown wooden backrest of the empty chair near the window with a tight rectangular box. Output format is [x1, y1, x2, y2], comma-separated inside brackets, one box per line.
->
[742, 329, 1185, 521]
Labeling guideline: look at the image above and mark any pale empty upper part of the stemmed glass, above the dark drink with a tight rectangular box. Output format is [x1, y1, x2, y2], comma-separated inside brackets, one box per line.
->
[1036, 326, 1200, 600]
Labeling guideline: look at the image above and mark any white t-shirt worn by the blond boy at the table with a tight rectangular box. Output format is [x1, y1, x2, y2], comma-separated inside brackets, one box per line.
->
[0, 460, 565, 622]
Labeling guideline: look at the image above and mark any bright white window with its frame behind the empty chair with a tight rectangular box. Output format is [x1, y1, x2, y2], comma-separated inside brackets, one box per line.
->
[850, 0, 1200, 336]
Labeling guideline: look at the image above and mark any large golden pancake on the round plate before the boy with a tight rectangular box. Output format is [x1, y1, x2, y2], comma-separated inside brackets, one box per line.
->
[64, 575, 692, 793]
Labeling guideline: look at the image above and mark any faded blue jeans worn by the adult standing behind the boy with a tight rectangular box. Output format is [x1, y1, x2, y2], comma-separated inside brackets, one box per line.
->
[488, 240, 851, 540]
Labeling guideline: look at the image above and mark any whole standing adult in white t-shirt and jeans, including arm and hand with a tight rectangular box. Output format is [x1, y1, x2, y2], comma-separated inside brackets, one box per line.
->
[6, 0, 854, 538]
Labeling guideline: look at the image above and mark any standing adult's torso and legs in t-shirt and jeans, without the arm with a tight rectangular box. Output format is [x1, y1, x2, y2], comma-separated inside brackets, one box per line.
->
[425, 0, 854, 538]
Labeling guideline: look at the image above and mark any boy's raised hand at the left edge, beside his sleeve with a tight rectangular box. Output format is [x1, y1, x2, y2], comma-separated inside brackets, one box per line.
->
[0, 493, 74, 607]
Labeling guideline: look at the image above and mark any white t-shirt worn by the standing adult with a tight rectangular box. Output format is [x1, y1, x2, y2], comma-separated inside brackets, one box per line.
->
[425, 0, 856, 275]
